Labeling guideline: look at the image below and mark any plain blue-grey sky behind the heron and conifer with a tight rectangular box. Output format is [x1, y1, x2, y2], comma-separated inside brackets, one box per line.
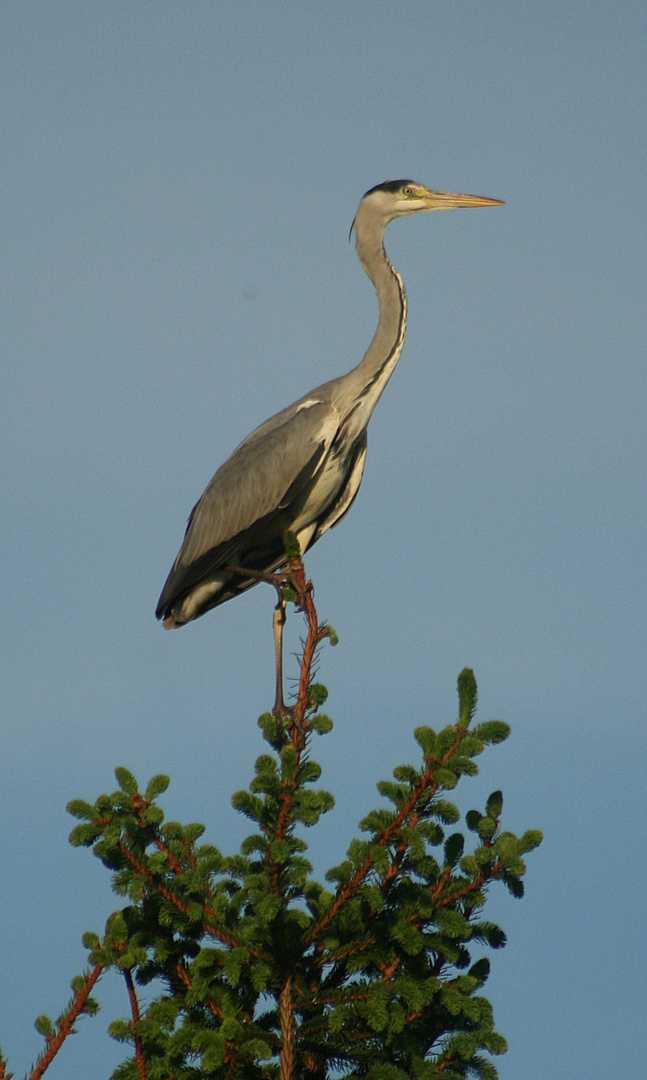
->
[0, 0, 647, 1080]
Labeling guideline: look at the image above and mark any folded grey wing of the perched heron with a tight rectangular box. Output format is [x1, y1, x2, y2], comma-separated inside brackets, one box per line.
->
[157, 399, 339, 618]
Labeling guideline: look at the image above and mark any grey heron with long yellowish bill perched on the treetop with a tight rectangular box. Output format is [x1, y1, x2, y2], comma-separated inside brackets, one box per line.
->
[156, 180, 501, 629]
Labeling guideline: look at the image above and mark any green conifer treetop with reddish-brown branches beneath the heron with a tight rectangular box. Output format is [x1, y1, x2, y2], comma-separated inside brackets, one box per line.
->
[0, 559, 541, 1080]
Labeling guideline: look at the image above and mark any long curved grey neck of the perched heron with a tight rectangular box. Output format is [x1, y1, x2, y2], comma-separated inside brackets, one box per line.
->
[350, 211, 407, 414]
